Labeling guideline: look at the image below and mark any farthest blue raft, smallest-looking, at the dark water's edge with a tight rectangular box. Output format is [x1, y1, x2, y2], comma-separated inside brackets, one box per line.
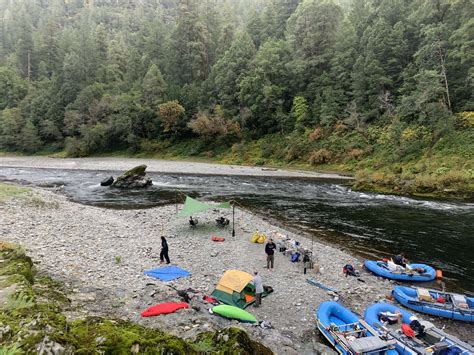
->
[364, 260, 436, 282]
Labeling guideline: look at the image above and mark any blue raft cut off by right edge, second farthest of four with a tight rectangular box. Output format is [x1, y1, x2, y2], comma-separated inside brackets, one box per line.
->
[392, 286, 474, 322]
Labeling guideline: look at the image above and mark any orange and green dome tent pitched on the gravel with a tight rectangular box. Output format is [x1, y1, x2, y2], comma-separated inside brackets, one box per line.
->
[211, 270, 268, 309]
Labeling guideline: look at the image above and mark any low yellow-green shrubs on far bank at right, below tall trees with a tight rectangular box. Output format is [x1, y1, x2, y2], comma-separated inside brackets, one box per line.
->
[217, 112, 474, 199]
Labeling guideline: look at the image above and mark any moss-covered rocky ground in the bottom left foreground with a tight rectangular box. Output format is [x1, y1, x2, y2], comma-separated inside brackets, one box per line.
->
[0, 242, 272, 354]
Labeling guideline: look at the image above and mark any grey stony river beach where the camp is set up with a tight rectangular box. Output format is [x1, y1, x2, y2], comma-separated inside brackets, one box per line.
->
[0, 186, 473, 354]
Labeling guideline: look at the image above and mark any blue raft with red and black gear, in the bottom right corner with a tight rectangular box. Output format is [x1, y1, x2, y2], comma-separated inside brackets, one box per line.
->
[364, 302, 474, 355]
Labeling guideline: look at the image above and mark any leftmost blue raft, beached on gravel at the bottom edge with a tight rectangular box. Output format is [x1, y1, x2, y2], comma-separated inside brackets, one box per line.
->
[316, 301, 398, 355]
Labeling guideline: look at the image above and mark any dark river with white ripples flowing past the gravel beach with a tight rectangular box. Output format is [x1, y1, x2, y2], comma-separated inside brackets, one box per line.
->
[0, 167, 474, 293]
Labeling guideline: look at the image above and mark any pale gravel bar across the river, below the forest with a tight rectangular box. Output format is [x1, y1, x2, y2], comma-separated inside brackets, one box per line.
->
[0, 156, 354, 181]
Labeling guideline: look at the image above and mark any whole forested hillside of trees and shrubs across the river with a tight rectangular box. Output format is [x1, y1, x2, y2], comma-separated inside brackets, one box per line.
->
[0, 0, 474, 196]
